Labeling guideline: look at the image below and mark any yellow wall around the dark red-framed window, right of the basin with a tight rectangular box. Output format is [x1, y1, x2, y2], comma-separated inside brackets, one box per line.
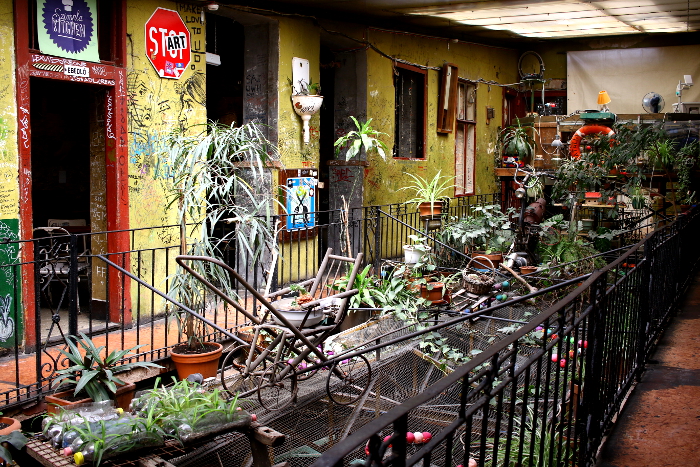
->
[365, 29, 518, 204]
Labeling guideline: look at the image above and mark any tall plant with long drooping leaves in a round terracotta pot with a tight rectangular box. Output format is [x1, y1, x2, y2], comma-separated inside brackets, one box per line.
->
[156, 123, 279, 378]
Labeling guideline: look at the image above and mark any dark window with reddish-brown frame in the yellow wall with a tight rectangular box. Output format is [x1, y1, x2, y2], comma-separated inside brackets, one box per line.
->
[394, 64, 428, 159]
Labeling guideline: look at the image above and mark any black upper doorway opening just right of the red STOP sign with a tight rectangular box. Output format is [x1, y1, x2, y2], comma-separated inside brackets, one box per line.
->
[207, 15, 245, 126]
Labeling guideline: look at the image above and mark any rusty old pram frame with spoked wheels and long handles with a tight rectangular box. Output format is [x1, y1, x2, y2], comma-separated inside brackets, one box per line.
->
[176, 248, 371, 410]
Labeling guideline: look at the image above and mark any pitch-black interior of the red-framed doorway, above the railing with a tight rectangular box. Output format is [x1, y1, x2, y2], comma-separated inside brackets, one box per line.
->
[30, 79, 94, 228]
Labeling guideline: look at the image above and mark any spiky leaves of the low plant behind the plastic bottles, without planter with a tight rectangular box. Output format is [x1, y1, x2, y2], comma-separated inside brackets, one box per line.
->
[56, 332, 162, 402]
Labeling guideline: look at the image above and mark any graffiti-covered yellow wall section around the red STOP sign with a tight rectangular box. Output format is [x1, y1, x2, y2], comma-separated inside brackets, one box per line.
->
[127, 0, 206, 313]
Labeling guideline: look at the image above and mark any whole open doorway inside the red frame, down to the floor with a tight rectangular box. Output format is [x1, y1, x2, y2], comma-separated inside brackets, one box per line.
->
[30, 78, 107, 339]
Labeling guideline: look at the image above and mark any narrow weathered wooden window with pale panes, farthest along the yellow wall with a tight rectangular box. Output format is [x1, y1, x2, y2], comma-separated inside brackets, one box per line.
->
[455, 80, 476, 196]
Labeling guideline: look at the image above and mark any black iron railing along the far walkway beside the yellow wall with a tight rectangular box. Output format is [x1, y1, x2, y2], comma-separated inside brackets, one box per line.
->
[0, 194, 667, 414]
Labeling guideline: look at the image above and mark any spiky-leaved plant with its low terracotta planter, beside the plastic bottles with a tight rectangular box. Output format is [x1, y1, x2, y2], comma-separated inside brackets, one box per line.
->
[46, 332, 163, 413]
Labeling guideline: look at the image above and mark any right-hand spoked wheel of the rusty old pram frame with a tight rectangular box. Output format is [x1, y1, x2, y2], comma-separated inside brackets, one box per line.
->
[326, 355, 372, 405]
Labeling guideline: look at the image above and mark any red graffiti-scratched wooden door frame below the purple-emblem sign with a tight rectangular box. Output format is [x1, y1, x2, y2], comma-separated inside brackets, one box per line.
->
[14, 0, 131, 348]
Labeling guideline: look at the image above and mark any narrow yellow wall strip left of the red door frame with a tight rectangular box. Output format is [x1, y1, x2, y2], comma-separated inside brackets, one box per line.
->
[0, 0, 19, 222]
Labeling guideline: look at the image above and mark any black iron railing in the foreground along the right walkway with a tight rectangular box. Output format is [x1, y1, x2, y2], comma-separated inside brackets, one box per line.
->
[313, 210, 700, 467]
